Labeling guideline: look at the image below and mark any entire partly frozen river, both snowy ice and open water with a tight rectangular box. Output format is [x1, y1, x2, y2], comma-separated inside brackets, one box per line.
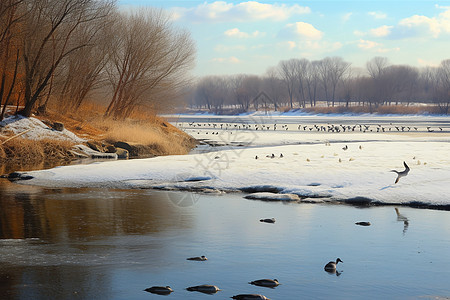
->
[0, 116, 450, 299]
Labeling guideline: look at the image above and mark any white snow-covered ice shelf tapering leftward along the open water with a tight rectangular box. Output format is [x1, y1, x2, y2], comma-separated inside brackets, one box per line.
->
[15, 140, 450, 206]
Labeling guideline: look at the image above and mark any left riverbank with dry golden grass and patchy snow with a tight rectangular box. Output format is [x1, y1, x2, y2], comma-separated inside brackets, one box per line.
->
[0, 111, 196, 173]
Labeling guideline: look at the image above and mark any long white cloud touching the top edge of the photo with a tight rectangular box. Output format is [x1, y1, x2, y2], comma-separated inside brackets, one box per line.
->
[173, 1, 311, 22]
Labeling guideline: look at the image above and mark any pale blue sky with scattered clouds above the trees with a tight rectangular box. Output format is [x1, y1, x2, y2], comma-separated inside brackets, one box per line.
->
[118, 0, 450, 76]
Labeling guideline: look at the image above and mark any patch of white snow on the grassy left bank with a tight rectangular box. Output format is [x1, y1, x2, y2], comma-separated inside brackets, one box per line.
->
[0, 116, 85, 143]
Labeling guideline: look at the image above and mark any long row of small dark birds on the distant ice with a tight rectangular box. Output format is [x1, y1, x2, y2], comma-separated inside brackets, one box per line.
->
[180, 122, 444, 135]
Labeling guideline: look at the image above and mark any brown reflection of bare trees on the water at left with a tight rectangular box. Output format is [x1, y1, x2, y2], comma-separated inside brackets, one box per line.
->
[0, 183, 189, 243]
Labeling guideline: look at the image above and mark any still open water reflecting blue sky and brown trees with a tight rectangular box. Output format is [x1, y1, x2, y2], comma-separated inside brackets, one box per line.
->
[0, 180, 450, 299]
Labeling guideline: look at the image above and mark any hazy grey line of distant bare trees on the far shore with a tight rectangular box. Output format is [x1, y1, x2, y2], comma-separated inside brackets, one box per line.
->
[185, 57, 450, 114]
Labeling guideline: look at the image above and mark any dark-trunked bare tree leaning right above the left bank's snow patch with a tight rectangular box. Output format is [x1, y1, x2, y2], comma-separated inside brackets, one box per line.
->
[20, 0, 112, 116]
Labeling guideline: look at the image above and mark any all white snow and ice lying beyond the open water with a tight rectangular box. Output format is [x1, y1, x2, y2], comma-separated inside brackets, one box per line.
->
[12, 116, 450, 206]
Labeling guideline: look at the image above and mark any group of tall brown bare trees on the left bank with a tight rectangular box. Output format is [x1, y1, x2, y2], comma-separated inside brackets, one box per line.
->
[0, 0, 196, 120]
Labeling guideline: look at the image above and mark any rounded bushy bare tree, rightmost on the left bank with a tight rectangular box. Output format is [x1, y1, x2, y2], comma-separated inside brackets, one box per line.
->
[105, 9, 195, 118]
